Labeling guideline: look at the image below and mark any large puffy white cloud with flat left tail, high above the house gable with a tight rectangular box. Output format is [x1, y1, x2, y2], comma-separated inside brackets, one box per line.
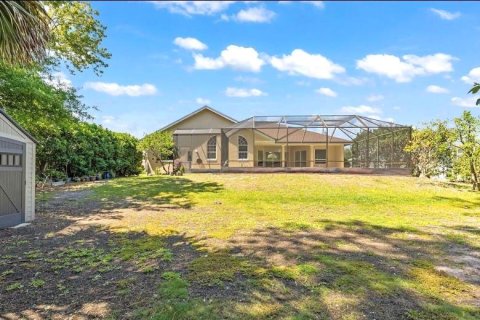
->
[193, 45, 265, 72]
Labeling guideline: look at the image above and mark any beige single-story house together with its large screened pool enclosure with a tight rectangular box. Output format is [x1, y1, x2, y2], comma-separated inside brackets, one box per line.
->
[144, 106, 412, 174]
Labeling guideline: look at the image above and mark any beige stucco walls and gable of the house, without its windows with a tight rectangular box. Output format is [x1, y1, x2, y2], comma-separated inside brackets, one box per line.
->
[145, 107, 346, 172]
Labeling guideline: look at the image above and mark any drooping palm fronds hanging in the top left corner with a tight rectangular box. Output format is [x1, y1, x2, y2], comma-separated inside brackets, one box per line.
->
[0, 1, 50, 65]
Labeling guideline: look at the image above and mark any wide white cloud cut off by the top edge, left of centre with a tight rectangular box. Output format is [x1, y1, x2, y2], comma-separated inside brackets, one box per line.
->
[151, 1, 235, 16]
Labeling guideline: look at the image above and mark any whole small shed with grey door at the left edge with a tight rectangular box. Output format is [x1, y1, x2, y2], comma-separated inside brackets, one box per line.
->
[0, 108, 36, 228]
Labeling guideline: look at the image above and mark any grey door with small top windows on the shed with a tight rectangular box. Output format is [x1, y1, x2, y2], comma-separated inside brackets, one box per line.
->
[0, 137, 25, 228]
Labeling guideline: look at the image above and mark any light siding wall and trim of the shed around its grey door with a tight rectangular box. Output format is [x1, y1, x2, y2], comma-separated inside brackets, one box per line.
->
[0, 113, 36, 222]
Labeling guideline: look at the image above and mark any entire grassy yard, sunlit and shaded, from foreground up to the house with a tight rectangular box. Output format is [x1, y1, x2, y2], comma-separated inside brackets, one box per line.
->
[0, 174, 480, 320]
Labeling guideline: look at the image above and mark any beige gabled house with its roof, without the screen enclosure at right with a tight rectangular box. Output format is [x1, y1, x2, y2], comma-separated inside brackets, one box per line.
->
[144, 106, 358, 172]
